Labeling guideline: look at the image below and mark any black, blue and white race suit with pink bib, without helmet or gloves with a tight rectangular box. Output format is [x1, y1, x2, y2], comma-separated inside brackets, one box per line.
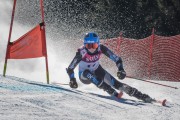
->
[67, 44, 152, 102]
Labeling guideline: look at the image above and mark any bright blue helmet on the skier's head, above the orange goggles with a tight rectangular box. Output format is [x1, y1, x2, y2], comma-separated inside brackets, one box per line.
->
[84, 32, 99, 45]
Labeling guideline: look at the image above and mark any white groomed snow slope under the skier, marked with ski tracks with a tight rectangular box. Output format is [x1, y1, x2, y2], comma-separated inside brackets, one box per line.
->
[0, 75, 180, 120]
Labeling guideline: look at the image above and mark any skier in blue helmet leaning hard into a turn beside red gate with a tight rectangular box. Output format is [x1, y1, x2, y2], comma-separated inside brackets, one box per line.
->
[66, 32, 153, 103]
